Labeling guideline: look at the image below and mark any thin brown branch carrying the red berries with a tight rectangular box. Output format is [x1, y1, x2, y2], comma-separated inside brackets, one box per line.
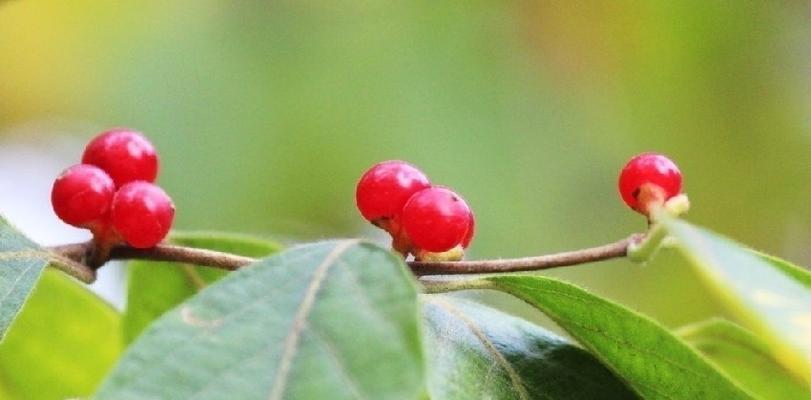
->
[48, 234, 644, 277]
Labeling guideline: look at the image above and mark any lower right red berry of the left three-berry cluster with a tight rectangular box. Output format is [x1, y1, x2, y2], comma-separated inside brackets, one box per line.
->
[111, 181, 175, 249]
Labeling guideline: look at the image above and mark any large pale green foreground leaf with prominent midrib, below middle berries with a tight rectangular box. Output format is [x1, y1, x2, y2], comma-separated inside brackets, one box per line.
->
[98, 241, 424, 400]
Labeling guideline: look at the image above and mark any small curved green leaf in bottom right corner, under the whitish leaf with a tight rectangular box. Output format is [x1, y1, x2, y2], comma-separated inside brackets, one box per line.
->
[678, 319, 811, 400]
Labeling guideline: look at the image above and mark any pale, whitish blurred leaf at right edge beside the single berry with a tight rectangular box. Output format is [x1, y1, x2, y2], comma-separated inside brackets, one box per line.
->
[663, 219, 811, 383]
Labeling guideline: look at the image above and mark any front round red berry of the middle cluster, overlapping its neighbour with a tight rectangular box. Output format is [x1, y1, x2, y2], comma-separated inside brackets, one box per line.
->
[402, 186, 473, 253]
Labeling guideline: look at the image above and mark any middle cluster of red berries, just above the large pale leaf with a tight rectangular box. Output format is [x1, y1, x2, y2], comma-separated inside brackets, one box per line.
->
[355, 161, 475, 259]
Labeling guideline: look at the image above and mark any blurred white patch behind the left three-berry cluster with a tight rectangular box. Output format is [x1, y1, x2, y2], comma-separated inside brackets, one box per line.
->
[0, 124, 125, 309]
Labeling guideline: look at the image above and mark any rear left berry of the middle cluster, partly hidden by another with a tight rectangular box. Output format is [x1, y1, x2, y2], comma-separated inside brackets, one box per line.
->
[355, 160, 431, 222]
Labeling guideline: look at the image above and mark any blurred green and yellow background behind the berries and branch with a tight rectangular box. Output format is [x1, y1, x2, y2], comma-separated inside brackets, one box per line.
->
[0, 0, 811, 326]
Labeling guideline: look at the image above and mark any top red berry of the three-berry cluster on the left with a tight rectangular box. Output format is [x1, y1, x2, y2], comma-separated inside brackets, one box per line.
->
[82, 129, 158, 187]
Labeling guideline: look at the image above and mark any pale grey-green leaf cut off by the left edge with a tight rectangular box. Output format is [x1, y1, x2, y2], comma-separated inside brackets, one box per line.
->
[0, 216, 51, 340]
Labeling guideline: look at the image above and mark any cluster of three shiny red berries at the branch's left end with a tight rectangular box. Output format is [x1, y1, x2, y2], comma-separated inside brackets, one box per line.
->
[51, 129, 175, 248]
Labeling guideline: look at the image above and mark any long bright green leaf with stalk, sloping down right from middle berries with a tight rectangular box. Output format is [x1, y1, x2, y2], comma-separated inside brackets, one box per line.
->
[437, 274, 750, 400]
